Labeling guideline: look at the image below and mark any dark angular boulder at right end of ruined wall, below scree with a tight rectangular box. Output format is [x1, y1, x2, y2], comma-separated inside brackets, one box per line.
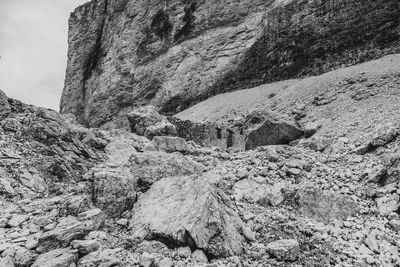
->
[245, 118, 304, 150]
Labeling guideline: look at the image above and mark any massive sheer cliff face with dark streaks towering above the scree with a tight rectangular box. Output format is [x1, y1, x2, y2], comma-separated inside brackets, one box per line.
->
[61, 0, 400, 127]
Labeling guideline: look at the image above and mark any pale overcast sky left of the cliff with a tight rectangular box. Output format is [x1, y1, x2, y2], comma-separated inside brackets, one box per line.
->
[0, 0, 88, 111]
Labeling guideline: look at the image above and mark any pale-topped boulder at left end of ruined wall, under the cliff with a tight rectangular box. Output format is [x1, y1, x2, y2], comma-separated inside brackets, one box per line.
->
[128, 106, 177, 139]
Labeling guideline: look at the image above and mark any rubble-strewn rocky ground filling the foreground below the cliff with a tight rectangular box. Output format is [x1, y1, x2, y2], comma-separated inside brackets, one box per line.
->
[0, 51, 400, 267]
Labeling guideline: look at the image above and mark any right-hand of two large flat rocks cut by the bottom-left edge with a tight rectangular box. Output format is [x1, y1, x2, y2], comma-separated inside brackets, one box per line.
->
[77, 249, 121, 267]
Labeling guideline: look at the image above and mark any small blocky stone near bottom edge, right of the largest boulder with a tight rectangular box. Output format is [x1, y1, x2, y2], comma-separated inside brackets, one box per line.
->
[267, 239, 300, 261]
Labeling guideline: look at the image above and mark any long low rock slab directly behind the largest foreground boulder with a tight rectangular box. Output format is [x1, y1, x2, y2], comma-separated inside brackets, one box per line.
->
[129, 151, 205, 191]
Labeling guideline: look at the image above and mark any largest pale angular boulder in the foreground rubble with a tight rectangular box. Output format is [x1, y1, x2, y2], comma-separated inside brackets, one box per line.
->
[130, 175, 243, 257]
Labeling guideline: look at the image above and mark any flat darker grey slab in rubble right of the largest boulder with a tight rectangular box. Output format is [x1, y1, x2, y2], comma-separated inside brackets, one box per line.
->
[297, 187, 359, 224]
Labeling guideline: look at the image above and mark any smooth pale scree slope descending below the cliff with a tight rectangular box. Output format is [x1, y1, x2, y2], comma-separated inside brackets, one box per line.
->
[175, 54, 400, 148]
